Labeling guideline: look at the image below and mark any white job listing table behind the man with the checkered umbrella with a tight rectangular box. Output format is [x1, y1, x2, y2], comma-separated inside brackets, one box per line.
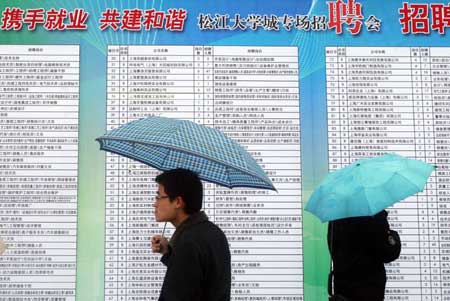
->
[105, 46, 303, 300]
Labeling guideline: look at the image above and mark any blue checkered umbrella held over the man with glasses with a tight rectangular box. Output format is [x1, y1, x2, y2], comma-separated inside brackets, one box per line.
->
[96, 117, 275, 190]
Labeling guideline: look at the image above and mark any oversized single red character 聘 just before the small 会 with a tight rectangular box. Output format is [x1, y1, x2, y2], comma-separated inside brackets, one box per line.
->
[327, 0, 364, 35]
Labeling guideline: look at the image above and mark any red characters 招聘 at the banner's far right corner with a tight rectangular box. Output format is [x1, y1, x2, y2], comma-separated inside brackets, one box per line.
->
[398, 2, 450, 34]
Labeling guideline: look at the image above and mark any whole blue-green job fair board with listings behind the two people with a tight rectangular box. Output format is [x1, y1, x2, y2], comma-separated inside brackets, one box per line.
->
[0, 0, 450, 301]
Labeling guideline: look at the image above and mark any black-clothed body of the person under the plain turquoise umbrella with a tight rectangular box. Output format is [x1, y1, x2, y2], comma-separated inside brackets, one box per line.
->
[328, 210, 389, 301]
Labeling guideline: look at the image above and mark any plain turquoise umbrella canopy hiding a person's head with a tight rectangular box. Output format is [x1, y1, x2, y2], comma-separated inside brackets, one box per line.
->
[305, 154, 434, 222]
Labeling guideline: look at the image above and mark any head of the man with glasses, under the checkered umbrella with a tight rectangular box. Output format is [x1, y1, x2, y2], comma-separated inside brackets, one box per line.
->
[154, 168, 203, 222]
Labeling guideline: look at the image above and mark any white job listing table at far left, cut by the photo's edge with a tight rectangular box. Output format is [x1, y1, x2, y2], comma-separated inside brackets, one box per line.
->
[0, 45, 79, 301]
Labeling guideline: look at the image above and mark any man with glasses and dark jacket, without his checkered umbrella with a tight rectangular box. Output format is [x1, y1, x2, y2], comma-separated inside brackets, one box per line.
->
[152, 169, 231, 301]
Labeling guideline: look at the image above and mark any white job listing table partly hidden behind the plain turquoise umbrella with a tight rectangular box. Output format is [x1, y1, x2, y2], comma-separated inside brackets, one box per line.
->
[326, 47, 450, 300]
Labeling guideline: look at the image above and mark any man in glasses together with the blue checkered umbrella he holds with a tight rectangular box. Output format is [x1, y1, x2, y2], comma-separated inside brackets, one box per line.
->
[96, 116, 276, 301]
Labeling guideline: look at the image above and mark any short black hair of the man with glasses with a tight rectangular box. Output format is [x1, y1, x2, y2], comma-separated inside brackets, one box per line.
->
[155, 168, 203, 214]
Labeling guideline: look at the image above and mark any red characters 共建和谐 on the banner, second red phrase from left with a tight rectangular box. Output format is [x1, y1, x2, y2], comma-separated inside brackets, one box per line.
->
[99, 8, 187, 31]
